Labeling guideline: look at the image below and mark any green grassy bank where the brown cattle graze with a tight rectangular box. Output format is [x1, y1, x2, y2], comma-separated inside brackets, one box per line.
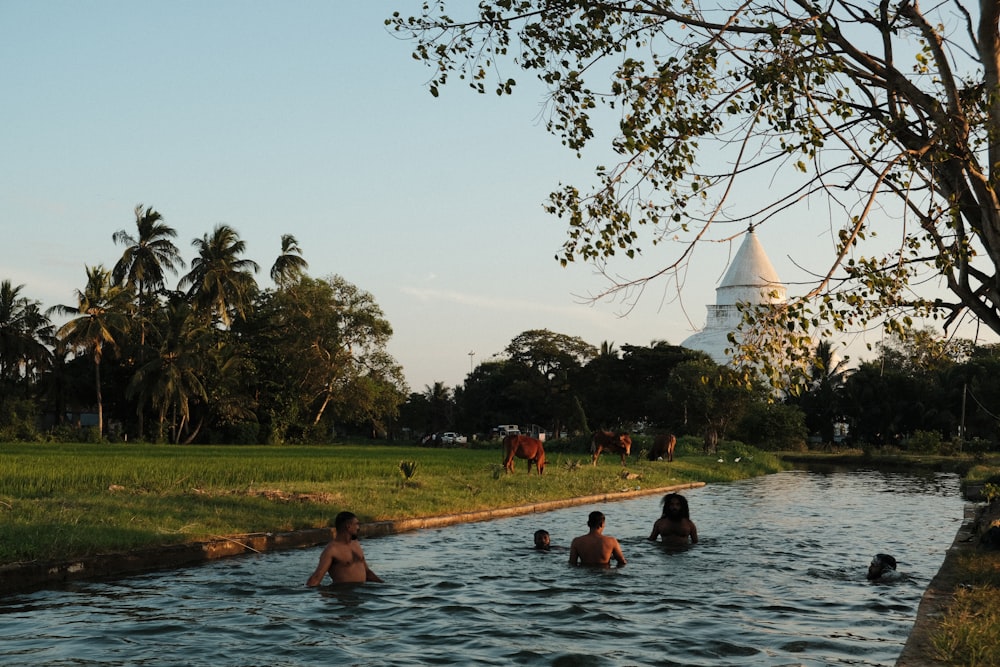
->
[0, 443, 781, 565]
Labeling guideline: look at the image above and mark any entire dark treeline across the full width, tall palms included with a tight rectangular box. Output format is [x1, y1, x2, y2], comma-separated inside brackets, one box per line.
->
[0, 205, 1000, 451]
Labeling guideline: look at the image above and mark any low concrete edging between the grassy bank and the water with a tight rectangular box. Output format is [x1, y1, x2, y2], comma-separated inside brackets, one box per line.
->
[0, 482, 705, 595]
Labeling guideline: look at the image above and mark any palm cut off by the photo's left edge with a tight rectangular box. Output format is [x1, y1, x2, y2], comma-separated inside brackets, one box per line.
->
[0, 280, 54, 393]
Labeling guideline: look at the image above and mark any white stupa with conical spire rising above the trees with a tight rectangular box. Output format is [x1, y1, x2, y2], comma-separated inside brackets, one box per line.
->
[681, 227, 787, 364]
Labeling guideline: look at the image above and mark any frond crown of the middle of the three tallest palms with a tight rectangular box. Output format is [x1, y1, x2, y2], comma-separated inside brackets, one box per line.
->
[180, 224, 260, 327]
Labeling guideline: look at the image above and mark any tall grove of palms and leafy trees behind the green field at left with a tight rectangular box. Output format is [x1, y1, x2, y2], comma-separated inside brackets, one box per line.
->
[0, 205, 407, 443]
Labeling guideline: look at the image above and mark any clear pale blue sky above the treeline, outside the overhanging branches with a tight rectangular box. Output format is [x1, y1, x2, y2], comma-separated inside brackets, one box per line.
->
[0, 0, 992, 392]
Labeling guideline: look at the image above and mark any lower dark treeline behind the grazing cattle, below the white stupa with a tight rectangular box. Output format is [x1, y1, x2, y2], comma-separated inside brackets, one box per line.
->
[401, 330, 1000, 453]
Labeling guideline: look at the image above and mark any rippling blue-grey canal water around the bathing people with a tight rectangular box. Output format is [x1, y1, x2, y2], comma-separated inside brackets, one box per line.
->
[0, 471, 963, 667]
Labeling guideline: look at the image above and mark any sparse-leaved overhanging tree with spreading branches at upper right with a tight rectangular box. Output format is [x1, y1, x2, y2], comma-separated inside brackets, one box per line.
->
[387, 0, 1000, 386]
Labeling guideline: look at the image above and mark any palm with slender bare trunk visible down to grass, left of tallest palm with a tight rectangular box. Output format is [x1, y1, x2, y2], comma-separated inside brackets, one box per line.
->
[48, 266, 132, 437]
